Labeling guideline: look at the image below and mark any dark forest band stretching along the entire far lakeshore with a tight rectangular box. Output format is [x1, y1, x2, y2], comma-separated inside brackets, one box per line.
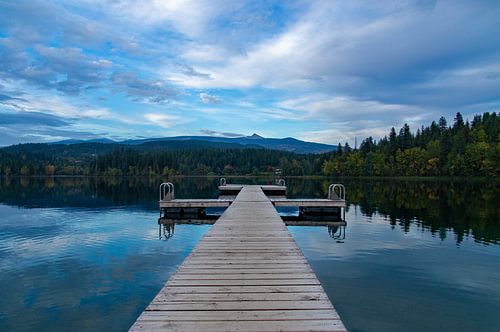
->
[0, 112, 500, 177]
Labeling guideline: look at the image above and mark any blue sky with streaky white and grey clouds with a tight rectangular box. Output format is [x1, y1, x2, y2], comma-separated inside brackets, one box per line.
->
[0, 0, 500, 146]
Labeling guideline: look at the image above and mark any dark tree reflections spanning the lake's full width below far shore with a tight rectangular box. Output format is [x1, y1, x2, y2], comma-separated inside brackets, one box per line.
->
[0, 177, 500, 243]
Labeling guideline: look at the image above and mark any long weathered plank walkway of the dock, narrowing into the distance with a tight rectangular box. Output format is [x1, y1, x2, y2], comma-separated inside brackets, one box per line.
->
[130, 186, 345, 332]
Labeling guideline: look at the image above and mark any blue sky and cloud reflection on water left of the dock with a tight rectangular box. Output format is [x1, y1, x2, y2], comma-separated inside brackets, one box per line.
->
[0, 205, 210, 330]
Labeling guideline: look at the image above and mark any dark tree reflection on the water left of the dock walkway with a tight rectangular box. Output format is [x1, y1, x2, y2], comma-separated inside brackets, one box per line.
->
[0, 177, 226, 208]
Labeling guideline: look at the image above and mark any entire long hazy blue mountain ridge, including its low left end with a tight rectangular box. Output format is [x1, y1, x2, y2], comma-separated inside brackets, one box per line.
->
[51, 134, 337, 154]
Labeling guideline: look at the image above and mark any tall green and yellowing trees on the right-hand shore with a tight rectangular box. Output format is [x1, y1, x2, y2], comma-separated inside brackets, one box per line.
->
[322, 113, 500, 177]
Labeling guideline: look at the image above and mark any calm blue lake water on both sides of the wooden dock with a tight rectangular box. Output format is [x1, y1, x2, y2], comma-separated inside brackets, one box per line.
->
[0, 178, 500, 331]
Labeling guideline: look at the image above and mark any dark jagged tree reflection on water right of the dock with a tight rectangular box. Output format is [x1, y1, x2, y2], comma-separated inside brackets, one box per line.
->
[346, 179, 500, 243]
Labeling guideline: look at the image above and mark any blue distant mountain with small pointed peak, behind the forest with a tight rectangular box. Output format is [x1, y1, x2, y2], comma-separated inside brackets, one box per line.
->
[120, 134, 337, 154]
